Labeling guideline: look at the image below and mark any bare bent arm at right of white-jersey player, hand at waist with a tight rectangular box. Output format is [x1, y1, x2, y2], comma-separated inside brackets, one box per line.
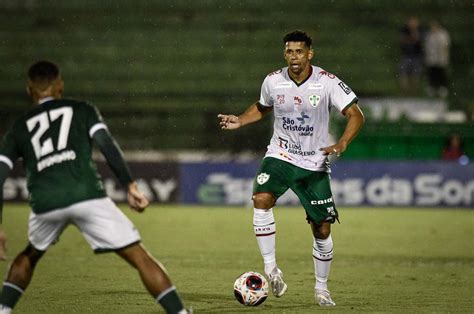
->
[321, 103, 365, 156]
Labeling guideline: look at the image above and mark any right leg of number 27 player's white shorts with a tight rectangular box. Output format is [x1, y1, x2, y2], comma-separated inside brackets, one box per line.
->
[73, 197, 140, 253]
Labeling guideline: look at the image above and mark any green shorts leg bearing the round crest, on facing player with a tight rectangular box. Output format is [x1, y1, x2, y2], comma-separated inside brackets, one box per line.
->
[253, 157, 294, 200]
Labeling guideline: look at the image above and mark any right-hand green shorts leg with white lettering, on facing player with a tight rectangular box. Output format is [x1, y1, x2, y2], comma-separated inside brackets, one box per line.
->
[291, 170, 338, 225]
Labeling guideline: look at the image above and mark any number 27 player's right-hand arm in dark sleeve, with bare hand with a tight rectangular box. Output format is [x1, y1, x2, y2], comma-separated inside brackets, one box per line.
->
[92, 128, 149, 212]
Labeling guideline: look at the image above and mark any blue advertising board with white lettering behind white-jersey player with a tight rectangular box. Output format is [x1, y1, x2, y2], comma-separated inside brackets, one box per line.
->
[179, 161, 474, 208]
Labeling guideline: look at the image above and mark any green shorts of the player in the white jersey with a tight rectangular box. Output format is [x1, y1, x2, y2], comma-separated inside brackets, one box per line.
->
[253, 157, 339, 225]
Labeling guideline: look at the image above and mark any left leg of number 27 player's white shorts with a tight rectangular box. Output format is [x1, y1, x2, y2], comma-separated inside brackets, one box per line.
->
[28, 208, 70, 251]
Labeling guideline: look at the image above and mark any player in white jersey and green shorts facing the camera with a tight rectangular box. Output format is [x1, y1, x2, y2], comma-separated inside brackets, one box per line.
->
[218, 31, 364, 306]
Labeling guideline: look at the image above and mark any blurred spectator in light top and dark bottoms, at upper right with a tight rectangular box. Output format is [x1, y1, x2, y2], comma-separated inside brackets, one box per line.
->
[424, 21, 451, 98]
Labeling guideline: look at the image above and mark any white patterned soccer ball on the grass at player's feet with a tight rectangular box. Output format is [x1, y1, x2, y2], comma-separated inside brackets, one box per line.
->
[234, 271, 268, 306]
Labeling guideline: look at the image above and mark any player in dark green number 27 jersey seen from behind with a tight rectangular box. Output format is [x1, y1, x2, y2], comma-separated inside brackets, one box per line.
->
[0, 61, 187, 313]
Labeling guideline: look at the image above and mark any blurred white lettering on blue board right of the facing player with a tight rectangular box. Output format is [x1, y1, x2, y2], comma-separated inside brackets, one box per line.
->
[331, 173, 474, 207]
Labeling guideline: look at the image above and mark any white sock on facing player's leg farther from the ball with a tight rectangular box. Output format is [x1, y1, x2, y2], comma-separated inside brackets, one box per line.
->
[313, 235, 333, 289]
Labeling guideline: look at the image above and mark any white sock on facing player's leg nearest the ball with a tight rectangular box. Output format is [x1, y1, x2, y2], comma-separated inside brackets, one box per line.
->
[253, 208, 276, 275]
